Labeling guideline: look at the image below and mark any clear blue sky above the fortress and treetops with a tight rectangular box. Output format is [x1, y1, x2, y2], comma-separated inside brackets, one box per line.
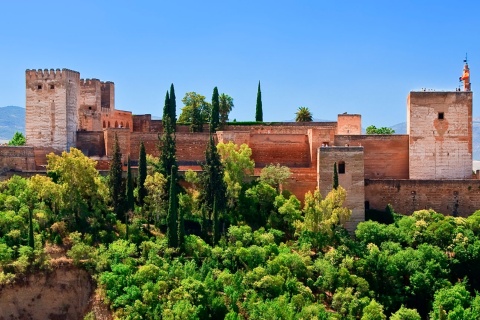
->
[0, 0, 480, 127]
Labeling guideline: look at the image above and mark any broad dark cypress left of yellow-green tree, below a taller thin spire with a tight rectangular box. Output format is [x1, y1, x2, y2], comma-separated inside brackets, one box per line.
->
[201, 135, 227, 241]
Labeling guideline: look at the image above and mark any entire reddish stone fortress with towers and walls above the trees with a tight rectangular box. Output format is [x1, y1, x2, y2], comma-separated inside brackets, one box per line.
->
[0, 62, 480, 229]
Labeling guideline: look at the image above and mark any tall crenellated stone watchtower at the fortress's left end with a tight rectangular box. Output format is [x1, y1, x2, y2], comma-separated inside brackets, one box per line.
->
[25, 69, 80, 150]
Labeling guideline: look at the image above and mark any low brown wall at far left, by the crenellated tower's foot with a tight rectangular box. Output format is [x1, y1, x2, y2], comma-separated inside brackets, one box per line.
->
[0, 146, 36, 171]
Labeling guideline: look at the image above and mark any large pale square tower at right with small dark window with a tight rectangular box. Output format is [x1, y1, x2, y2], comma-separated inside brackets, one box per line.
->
[407, 91, 473, 179]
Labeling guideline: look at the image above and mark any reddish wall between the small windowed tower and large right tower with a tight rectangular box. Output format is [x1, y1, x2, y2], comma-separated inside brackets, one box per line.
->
[335, 134, 409, 179]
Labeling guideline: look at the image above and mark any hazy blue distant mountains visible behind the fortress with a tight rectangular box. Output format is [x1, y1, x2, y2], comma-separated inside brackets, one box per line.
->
[0, 106, 480, 160]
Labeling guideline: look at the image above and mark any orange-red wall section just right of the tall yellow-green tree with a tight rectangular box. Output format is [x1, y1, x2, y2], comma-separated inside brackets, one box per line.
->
[249, 134, 311, 167]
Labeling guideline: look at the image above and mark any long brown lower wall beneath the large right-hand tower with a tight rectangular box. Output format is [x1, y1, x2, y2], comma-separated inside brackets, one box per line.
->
[365, 179, 480, 217]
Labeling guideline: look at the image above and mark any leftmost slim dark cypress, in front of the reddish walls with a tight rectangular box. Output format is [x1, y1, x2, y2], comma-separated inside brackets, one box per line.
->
[108, 134, 125, 219]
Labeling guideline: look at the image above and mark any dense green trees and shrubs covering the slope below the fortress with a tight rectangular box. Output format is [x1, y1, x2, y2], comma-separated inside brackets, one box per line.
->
[0, 144, 480, 320]
